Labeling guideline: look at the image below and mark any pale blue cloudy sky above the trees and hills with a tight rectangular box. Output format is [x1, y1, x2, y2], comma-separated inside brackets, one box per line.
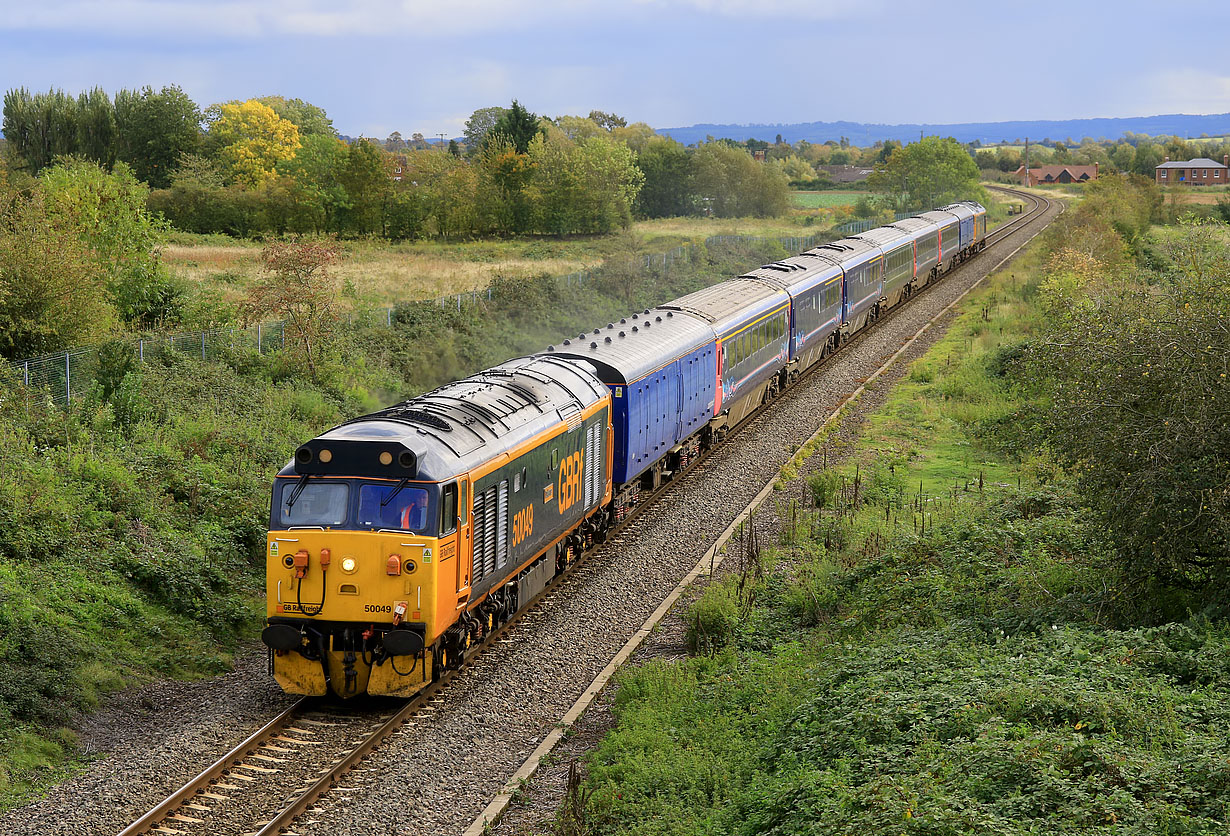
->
[0, 0, 1230, 139]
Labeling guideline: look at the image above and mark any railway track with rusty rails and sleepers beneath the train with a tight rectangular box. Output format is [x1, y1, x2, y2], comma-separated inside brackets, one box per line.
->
[119, 189, 1052, 836]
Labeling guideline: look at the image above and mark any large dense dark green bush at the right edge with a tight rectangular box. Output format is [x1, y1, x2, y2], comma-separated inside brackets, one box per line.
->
[1028, 218, 1230, 595]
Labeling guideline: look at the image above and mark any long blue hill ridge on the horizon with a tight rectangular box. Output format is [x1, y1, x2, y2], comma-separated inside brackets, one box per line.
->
[658, 113, 1230, 145]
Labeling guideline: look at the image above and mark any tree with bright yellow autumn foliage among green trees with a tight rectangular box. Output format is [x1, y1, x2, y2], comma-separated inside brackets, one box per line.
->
[209, 98, 299, 188]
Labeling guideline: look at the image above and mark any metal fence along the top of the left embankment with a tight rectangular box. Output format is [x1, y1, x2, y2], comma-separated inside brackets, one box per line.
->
[9, 235, 831, 407]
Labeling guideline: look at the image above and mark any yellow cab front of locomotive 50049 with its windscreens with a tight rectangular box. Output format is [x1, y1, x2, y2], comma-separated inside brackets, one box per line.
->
[262, 469, 455, 697]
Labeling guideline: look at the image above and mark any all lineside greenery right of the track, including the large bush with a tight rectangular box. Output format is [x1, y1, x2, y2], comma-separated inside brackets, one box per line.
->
[556, 178, 1230, 835]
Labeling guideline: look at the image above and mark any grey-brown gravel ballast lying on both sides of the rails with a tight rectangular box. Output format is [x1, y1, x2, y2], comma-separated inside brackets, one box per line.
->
[0, 197, 1054, 836]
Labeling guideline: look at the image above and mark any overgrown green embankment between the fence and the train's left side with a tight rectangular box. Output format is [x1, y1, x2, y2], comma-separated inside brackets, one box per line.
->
[0, 233, 785, 810]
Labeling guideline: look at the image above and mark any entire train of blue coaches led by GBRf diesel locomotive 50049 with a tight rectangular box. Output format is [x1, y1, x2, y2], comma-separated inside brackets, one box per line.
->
[261, 202, 986, 697]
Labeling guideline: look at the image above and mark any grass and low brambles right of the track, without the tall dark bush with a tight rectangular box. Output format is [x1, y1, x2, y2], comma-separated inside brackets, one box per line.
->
[573, 224, 1230, 836]
